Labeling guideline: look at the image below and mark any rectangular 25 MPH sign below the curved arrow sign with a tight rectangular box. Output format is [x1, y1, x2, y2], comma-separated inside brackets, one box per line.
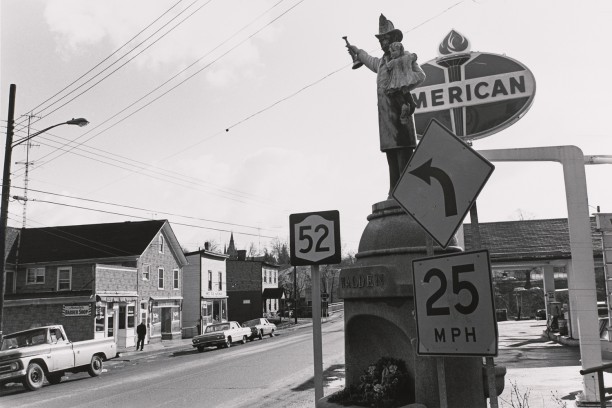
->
[412, 250, 498, 356]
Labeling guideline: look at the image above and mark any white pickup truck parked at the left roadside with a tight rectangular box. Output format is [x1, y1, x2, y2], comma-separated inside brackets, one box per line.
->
[0, 325, 117, 391]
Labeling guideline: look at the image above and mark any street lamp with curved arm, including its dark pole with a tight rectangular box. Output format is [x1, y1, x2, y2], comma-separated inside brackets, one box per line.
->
[0, 84, 89, 339]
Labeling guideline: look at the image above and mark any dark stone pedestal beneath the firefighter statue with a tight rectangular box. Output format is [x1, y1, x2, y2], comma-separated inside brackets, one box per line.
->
[339, 199, 505, 408]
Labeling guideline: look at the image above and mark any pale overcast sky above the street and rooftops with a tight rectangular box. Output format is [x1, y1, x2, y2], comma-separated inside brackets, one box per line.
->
[0, 0, 612, 252]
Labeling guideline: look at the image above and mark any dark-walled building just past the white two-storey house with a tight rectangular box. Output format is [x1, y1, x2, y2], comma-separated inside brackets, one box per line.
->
[227, 251, 284, 322]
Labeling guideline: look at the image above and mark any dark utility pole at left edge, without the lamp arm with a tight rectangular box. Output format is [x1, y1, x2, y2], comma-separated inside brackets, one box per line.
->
[0, 84, 17, 339]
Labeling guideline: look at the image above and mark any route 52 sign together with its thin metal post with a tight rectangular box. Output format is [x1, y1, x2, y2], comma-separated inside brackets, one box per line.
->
[289, 211, 342, 404]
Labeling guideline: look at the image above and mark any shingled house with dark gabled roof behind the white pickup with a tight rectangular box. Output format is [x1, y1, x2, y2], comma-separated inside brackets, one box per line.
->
[4, 220, 187, 347]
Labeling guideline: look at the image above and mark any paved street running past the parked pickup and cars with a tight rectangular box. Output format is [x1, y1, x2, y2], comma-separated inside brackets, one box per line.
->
[0, 317, 344, 408]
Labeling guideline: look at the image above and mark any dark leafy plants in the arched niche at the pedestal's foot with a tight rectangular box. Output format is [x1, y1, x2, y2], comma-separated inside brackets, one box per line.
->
[328, 357, 412, 408]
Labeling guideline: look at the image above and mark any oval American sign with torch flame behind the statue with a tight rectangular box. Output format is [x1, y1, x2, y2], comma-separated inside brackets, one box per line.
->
[412, 30, 536, 141]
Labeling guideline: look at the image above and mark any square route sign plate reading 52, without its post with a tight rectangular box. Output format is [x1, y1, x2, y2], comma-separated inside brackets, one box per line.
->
[289, 210, 342, 266]
